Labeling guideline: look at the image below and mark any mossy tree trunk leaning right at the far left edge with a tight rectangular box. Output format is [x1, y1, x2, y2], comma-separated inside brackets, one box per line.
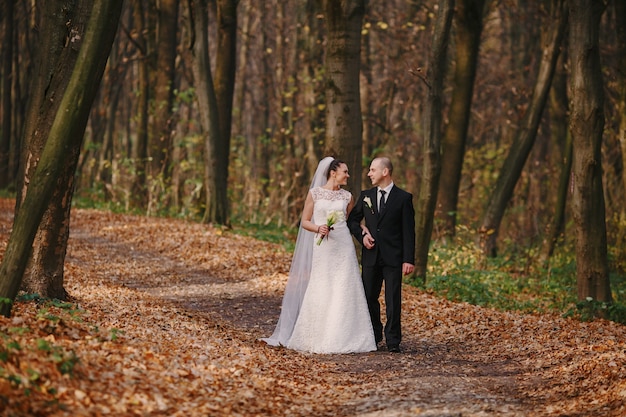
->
[0, 0, 123, 316]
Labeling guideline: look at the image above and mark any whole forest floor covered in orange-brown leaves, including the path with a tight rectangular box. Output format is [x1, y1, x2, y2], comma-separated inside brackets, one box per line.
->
[0, 200, 626, 417]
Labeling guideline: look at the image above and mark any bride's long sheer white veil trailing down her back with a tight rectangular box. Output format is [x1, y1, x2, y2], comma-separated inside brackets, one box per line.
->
[260, 157, 334, 346]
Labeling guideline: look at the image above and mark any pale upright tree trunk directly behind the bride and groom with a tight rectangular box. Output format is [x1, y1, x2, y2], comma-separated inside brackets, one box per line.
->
[323, 0, 366, 192]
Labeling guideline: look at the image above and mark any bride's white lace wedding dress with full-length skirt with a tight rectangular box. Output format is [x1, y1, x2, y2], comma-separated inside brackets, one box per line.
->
[286, 187, 376, 353]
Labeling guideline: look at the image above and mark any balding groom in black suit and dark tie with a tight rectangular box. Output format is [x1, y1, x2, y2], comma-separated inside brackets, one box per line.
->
[348, 157, 415, 352]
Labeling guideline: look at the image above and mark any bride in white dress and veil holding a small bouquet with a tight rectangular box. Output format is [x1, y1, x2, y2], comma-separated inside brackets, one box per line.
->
[261, 157, 376, 353]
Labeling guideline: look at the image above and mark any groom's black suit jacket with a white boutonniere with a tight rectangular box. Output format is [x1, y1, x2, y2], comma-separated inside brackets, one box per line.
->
[348, 185, 415, 267]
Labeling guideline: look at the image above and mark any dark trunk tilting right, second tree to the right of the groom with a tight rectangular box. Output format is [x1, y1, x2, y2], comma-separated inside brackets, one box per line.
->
[435, 0, 485, 236]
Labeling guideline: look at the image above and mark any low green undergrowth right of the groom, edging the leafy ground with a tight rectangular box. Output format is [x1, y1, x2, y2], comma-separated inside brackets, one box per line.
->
[408, 224, 626, 324]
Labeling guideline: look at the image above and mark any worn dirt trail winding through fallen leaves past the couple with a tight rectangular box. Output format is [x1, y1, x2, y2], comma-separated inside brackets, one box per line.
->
[71, 210, 535, 416]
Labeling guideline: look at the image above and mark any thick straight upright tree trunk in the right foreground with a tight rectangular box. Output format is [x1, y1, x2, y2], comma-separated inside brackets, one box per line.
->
[569, 0, 611, 301]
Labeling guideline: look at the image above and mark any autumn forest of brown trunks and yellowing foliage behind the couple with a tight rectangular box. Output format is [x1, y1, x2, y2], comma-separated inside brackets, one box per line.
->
[0, 0, 626, 316]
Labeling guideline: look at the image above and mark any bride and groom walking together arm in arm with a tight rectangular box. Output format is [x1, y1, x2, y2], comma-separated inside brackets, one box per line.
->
[261, 157, 415, 353]
